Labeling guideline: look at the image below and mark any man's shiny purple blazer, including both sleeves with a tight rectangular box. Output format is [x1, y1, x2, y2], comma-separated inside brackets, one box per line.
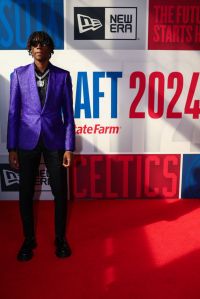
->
[7, 63, 75, 151]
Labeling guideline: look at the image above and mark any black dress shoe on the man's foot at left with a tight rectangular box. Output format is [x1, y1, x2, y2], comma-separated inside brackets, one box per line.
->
[17, 238, 37, 262]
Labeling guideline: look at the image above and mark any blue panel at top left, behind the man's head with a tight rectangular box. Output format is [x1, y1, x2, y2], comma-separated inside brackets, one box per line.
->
[0, 0, 64, 50]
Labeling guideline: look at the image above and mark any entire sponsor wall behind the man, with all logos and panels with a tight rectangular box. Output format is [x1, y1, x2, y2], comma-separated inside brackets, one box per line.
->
[0, 0, 200, 199]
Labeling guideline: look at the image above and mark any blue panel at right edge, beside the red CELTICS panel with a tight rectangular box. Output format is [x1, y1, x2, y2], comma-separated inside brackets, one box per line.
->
[181, 154, 200, 198]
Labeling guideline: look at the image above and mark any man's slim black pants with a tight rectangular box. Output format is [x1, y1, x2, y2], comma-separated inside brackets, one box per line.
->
[18, 139, 67, 238]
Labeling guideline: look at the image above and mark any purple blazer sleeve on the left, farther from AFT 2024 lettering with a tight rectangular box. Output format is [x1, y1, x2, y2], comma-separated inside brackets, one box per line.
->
[7, 70, 21, 150]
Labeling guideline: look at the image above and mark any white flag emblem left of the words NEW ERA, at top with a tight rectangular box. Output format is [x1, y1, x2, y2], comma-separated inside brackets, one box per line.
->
[77, 14, 103, 33]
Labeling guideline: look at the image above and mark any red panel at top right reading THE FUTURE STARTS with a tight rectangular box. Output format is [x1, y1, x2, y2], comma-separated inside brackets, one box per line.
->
[148, 0, 200, 50]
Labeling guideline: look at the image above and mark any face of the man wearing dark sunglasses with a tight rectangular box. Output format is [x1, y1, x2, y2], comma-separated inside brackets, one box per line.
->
[31, 40, 51, 62]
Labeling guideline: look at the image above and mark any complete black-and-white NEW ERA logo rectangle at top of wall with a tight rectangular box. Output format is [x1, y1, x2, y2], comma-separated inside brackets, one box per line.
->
[74, 7, 137, 40]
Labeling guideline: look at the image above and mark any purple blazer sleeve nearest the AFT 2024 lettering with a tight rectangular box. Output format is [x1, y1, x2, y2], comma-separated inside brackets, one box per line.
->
[62, 72, 75, 151]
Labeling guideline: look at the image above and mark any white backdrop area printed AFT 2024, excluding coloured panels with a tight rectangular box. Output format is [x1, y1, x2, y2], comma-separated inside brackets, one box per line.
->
[0, 0, 200, 199]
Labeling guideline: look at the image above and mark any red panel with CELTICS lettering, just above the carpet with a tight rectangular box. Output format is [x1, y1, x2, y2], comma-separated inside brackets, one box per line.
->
[72, 154, 180, 199]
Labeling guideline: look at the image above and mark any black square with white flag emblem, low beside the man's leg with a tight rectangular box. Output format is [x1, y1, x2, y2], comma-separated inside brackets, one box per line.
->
[0, 164, 19, 191]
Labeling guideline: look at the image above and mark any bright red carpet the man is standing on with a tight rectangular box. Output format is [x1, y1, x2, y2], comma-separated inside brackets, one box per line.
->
[0, 200, 200, 299]
